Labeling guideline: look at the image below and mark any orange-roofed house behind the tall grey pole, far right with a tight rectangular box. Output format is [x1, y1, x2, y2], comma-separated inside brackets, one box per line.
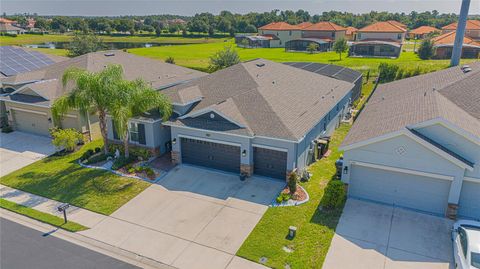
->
[432, 31, 480, 59]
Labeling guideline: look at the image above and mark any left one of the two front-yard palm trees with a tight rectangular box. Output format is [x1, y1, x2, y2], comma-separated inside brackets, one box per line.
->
[52, 65, 123, 154]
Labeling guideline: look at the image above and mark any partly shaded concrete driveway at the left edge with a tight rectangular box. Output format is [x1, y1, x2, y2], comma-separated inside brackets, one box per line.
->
[0, 132, 55, 177]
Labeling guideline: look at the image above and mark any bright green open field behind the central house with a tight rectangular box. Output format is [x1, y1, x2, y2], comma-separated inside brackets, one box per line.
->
[129, 40, 473, 76]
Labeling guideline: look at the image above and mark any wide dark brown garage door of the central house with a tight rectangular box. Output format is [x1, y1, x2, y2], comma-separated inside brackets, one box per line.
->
[181, 138, 240, 173]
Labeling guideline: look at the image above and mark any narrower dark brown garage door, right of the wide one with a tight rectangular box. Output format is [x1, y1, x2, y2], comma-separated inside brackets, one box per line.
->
[253, 147, 287, 180]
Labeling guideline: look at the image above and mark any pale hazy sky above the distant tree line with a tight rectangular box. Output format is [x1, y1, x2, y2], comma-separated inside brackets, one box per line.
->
[0, 0, 480, 16]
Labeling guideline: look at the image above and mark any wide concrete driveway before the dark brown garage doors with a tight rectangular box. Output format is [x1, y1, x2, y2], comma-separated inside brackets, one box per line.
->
[82, 165, 285, 269]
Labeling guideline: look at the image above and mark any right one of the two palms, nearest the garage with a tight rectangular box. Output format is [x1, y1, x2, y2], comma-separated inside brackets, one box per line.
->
[109, 79, 172, 158]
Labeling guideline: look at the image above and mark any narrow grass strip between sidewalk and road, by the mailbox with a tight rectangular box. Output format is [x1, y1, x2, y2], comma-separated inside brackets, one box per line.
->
[0, 198, 88, 232]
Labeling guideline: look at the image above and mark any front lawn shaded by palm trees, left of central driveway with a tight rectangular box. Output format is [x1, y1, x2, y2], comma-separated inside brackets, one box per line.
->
[0, 141, 150, 215]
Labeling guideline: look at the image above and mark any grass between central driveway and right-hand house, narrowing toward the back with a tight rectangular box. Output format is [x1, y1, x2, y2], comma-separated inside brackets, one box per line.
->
[237, 125, 350, 269]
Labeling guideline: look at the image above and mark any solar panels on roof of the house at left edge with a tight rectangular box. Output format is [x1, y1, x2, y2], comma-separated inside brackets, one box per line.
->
[0, 46, 55, 76]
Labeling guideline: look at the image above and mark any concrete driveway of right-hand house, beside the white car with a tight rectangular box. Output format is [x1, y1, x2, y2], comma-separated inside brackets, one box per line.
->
[323, 199, 453, 269]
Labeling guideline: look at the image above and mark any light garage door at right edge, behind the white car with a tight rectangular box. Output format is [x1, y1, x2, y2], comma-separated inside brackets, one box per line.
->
[458, 180, 480, 220]
